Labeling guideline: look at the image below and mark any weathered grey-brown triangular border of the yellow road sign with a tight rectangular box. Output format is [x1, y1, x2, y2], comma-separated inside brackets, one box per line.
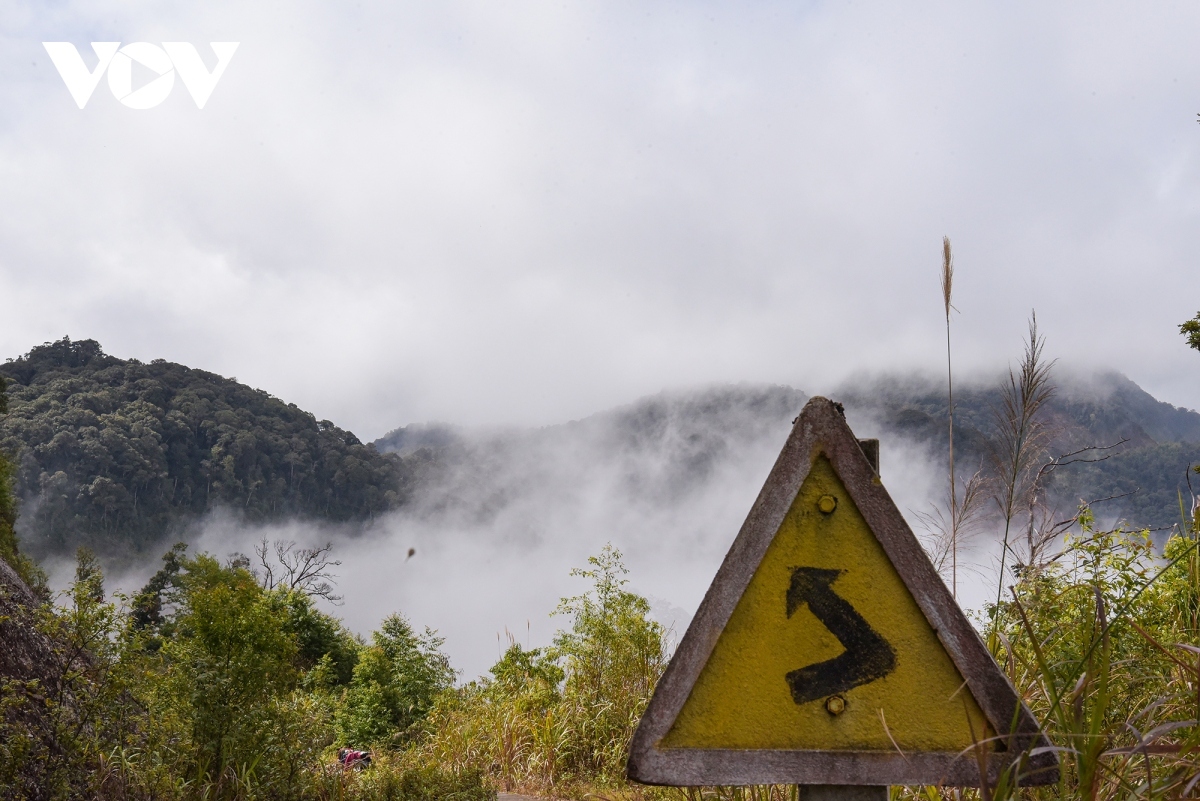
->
[628, 397, 1058, 787]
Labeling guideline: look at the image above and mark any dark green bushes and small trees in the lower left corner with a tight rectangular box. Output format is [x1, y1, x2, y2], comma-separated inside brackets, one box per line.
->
[0, 537, 494, 801]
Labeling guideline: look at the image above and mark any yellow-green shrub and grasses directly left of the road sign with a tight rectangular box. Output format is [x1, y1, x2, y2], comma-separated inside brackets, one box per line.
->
[419, 546, 667, 795]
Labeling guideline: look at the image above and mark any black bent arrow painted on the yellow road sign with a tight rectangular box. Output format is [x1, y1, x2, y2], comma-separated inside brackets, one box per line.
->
[787, 567, 896, 704]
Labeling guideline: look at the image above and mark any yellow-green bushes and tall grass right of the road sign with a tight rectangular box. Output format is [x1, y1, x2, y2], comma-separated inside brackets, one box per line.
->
[964, 507, 1200, 800]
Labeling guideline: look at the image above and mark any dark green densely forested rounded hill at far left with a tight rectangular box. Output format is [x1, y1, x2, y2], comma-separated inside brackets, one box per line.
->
[0, 339, 406, 555]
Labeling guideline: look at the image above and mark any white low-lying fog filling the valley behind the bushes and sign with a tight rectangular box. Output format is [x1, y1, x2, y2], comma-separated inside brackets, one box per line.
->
[77, 385, 1012, 680]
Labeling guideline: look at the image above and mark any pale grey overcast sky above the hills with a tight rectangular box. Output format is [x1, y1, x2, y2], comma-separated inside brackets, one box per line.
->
[0, 0, 1200, 439]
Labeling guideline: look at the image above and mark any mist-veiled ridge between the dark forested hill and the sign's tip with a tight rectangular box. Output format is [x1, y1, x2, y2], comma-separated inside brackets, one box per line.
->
[388, 385, 808, 520]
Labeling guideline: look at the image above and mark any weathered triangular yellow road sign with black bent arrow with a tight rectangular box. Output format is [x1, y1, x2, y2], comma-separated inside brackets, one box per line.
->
[628, 398, 1058, 797]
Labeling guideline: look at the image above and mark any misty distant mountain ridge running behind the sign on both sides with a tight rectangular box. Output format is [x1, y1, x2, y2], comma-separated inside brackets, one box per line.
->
[374, 371, 1200, 528]
